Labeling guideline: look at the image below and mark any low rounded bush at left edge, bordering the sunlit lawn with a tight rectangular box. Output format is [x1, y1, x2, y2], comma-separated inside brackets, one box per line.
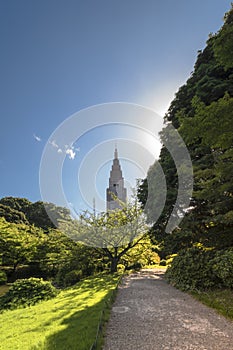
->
[0, 277, 57, 309]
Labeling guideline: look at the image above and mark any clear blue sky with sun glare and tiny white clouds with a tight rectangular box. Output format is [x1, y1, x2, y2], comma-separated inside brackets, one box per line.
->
[0, 0, 231, 210]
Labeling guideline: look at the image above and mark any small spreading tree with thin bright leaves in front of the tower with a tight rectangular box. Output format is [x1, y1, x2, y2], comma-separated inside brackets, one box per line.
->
[59, 202, 148, 273]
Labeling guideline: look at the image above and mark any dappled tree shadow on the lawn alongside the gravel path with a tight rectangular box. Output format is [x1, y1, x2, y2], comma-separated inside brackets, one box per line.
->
[33, 277, 118, 350]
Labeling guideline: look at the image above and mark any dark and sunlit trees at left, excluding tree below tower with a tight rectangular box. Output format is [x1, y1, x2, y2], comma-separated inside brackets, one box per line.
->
[0, 197, 103, 286]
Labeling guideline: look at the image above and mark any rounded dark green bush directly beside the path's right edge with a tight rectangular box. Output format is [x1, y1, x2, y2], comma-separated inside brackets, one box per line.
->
[165, 247, 220, 291]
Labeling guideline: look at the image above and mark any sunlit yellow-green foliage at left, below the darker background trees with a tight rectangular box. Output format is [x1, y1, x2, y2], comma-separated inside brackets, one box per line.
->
[0, 213, 105, 285]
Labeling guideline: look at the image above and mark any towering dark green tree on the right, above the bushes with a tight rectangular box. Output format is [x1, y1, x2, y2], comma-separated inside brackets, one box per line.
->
[138, 3, 233, 257]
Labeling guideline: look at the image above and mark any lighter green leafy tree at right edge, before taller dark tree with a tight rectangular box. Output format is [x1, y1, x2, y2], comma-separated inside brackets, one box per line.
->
[180, 94, 233, 248]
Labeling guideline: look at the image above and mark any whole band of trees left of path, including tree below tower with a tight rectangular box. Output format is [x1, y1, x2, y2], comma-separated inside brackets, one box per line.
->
[0, 197, 160, 286]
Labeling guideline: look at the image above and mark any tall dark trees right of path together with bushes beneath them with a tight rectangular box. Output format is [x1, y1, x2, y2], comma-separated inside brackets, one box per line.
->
[138, 8, 233, 289]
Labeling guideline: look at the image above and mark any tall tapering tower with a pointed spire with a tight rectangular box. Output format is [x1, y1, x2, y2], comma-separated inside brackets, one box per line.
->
[106, 148, 127, 210]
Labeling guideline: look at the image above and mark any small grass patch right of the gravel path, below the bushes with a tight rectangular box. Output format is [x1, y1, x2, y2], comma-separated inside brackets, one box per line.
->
[191, 289, 233, 320]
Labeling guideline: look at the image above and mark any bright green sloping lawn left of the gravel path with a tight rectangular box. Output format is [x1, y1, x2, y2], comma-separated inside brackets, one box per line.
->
[0, 275, 119, 350]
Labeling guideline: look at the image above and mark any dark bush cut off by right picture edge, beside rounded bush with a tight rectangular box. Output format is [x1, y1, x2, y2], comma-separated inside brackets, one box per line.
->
[211, 249, 233, 288]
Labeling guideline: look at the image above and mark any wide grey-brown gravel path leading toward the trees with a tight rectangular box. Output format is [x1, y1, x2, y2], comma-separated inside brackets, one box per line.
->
[104, 270, 233, 350]
